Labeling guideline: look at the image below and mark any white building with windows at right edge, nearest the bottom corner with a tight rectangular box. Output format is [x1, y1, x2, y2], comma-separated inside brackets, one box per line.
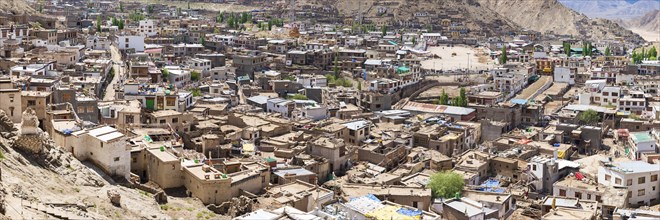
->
[598, 161, 660, 206]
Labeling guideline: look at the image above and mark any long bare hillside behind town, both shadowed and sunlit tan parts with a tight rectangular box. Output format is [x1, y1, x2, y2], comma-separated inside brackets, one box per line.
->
[296, 0, 643, 42]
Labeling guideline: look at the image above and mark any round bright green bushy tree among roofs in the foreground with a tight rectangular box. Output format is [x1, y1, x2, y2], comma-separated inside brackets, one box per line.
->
[428, 170, 465, 198]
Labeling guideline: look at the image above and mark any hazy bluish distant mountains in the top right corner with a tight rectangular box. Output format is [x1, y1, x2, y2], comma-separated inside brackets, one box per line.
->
[559, 0, 660, 19]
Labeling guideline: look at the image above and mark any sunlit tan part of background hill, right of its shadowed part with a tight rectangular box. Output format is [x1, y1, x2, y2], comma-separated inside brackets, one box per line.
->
[478, 0, 644, 42]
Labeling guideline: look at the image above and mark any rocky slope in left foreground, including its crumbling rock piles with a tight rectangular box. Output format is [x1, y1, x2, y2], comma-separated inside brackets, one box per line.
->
[0, 110, 213, 219]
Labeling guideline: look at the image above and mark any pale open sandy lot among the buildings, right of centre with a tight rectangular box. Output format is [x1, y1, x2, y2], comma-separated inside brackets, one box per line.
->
[422, 46, 495, 70]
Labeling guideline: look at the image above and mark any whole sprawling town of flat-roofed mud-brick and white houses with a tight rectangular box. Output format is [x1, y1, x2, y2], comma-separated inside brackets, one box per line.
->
[0, 1, 660, 219]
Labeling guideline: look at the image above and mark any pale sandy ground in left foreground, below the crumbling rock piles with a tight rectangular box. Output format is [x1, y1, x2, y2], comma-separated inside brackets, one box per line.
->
[0, 137, 219, 219]
